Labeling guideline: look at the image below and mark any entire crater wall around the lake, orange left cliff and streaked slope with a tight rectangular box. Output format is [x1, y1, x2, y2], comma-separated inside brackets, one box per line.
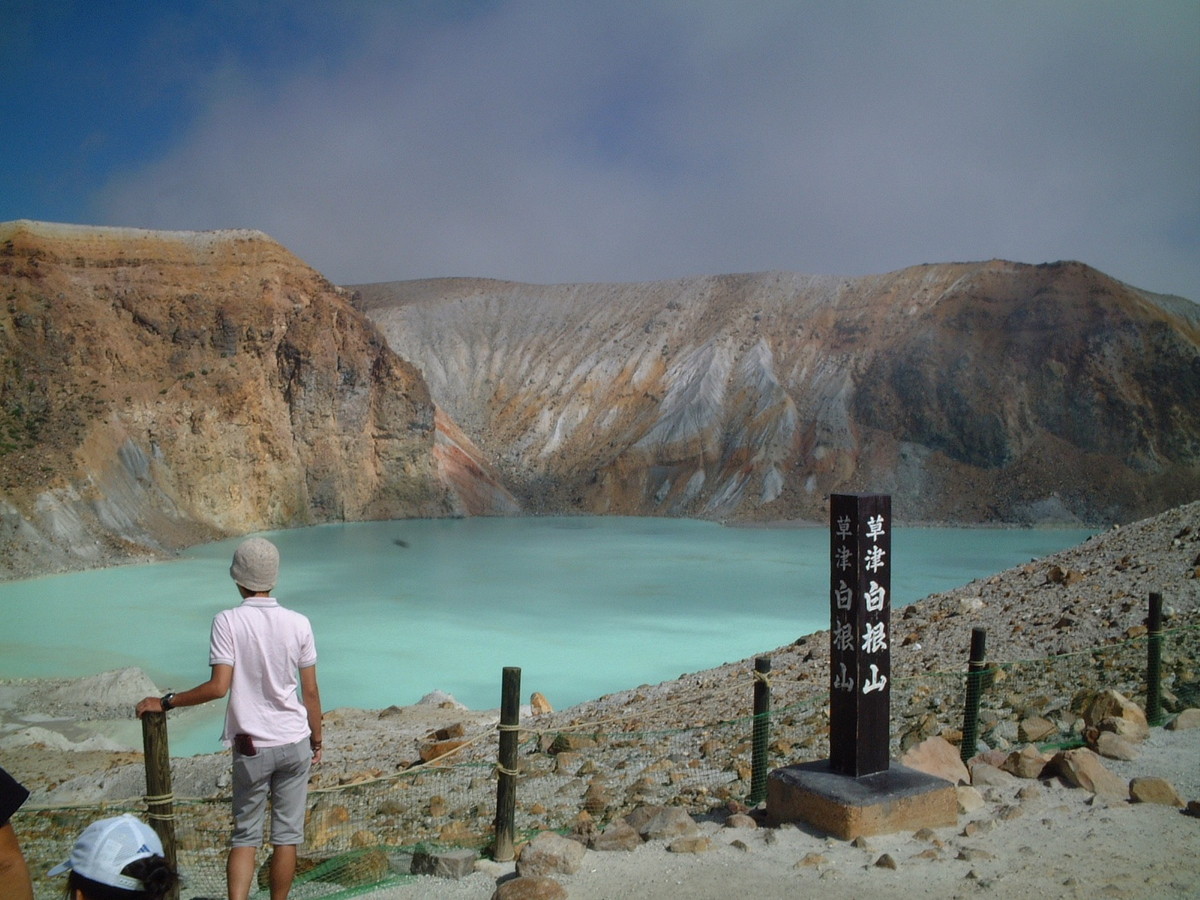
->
[0, 222, 1200, 578]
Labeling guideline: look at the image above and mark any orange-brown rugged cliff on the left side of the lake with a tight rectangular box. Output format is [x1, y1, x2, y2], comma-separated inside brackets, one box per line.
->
[0, 222, 462, 576]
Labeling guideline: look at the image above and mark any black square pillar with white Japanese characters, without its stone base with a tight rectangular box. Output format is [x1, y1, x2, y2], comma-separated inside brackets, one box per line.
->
[829, 493, 892, 778]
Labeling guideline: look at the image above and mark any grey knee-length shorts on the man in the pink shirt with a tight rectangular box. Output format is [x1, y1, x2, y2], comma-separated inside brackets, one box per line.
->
[229, 738, 312, 847]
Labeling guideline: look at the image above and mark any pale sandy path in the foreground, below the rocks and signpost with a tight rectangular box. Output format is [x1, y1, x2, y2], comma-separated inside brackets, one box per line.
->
[364, 728, 1200, 900]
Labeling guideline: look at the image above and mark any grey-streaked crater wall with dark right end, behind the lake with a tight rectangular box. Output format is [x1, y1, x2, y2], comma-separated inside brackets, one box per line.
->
[352, 260, 1200, 523]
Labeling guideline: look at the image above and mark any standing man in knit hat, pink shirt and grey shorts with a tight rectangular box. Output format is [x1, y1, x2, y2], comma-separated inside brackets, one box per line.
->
[137, 538, 322, 900]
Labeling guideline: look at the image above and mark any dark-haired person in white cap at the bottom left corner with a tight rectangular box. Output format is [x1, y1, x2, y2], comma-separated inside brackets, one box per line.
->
[49, 812, 179, 900]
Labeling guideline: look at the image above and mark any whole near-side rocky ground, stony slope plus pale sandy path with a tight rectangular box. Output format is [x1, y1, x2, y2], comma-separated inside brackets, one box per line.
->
[0, 502, 1200, 900]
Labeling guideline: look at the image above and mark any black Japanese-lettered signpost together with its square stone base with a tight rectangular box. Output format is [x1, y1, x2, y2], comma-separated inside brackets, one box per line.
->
[767, 494, 958, 840]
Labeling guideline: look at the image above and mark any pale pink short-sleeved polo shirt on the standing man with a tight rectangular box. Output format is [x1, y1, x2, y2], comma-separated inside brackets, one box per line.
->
[209, 596, 317, 746]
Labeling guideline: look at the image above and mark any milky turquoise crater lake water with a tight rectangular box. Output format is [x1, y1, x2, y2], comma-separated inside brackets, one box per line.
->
[0, 517, 1092, 755]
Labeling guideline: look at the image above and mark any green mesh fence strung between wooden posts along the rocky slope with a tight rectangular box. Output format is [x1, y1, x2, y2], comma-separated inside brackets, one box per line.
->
[13, 626, 1200, 900]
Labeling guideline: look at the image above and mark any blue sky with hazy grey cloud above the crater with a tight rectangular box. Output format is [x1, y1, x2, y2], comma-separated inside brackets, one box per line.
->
[0, 0, 1200, 301]
